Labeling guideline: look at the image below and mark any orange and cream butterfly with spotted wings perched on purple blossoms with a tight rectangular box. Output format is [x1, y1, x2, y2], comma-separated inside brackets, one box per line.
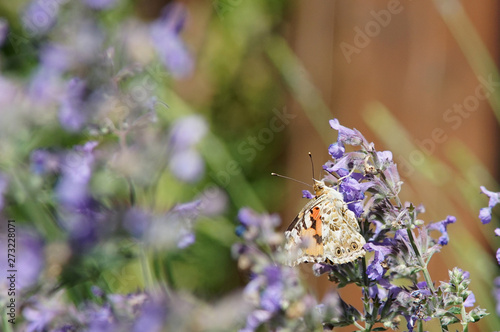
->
[284, 180, 366, 266]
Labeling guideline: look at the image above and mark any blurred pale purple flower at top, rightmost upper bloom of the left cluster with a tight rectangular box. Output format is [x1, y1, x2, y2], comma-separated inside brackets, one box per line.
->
[151, 3, 194, 78]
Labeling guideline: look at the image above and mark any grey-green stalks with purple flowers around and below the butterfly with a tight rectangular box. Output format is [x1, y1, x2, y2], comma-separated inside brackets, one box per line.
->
[236, 119, 488, 331]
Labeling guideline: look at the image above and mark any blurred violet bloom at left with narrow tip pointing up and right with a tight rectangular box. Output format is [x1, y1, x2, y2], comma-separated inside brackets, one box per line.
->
[55, 141, 98, 208]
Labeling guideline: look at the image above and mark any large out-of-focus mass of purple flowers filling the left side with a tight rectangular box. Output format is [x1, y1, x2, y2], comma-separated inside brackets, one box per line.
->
[0, 0, 225, 332]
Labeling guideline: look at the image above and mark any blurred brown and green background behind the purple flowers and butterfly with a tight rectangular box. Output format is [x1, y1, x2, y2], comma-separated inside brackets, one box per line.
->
[0, 0, 500, 331]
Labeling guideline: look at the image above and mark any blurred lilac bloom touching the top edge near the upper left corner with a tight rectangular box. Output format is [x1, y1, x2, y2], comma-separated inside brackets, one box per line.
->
[22, 0, 61, 35]
